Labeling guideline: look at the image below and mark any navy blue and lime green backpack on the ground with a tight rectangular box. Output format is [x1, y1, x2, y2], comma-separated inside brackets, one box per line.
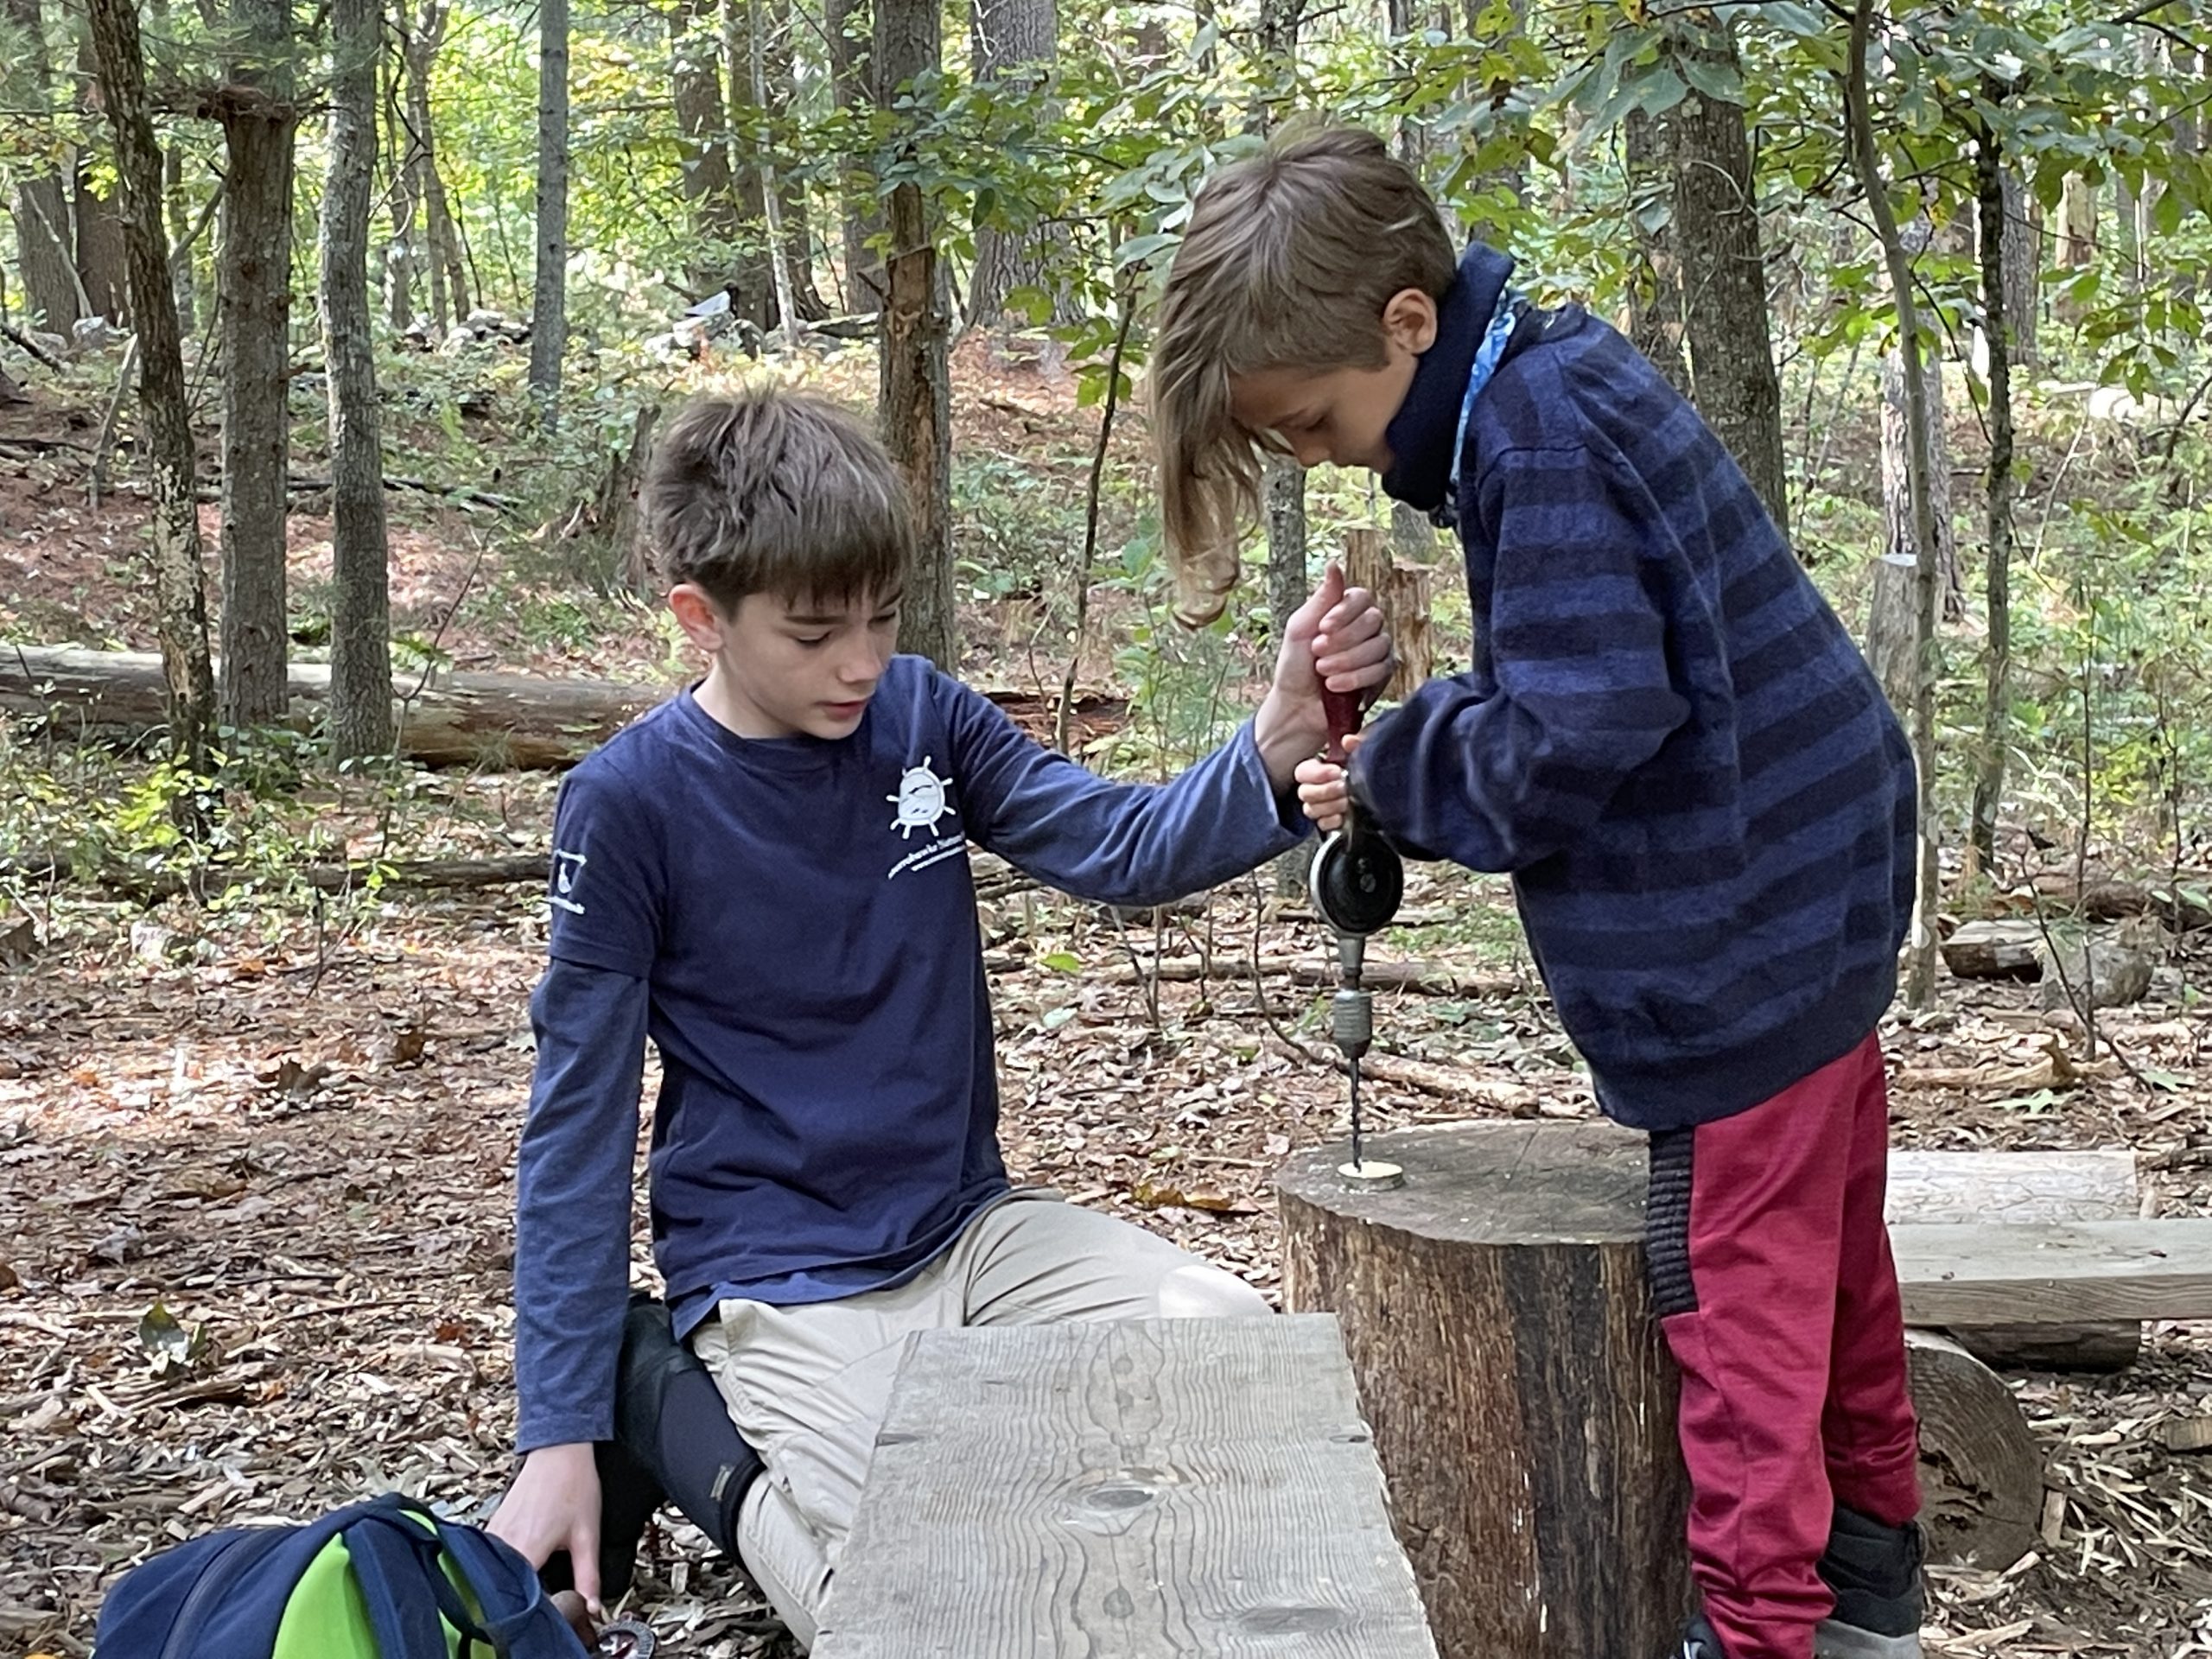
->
[93, 1493, 588, 1659]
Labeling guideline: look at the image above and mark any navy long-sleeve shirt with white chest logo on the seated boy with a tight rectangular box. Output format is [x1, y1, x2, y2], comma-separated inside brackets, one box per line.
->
[515, 657, 1305, 1451]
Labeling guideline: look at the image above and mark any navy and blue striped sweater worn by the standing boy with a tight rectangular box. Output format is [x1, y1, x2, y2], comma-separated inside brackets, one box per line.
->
[1354, 245, 1913, 1128]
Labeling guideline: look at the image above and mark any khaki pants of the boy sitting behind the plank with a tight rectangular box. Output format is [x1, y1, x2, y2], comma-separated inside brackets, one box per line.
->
[692, 1192, 1268, 1648]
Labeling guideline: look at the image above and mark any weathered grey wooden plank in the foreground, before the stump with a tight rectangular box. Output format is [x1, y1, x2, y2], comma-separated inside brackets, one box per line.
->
[814, 1316, 1435, 1659]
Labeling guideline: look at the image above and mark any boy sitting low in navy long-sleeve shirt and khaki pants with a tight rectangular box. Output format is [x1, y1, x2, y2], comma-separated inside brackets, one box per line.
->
[493, 382, 1389, 1646]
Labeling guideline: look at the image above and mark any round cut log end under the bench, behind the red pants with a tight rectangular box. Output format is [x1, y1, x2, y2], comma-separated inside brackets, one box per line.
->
[1904, 1332, 2044, 1573]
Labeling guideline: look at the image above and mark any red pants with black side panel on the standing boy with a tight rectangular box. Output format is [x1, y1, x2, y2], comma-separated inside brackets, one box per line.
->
[1650, 1035, 1920, 1659]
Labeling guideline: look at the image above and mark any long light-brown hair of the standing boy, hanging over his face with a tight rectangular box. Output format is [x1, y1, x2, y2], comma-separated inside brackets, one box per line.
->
[1150, 126, 1460, 621]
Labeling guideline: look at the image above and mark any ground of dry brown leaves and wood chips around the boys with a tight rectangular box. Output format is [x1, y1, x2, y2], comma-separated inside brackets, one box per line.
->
[0, 849, 2212, 1659]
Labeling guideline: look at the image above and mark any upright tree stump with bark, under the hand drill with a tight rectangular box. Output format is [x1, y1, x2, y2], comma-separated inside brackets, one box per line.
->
[1281, 1123, 1690, 1659]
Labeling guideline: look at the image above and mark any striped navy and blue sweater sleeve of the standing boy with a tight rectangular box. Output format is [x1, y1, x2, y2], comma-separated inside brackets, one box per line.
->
[1354, 445, 1690, 872]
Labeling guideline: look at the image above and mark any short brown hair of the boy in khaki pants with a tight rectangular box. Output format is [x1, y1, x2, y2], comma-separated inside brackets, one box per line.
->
[639, 387, 913, 613]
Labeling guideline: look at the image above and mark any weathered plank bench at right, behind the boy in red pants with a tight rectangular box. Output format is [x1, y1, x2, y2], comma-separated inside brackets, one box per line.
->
[1889, 1219, 2212, 1325]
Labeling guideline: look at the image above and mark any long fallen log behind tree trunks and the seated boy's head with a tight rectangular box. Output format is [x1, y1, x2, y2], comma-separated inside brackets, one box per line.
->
[0, 646, 1126, 772]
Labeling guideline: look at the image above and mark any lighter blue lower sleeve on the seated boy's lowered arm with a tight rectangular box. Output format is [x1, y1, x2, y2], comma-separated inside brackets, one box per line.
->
[515, 963, 648, 1451]
